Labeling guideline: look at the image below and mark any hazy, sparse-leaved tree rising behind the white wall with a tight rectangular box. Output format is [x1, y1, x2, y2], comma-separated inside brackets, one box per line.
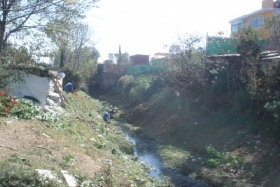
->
[48, 22, 100, 80]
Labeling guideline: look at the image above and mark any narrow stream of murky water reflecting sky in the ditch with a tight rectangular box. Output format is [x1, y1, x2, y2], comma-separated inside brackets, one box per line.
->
[118, 124, 209, 187]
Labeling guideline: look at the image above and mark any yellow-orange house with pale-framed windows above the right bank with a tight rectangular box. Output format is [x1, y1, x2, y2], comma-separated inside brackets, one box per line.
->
[229, 0, 280, 38]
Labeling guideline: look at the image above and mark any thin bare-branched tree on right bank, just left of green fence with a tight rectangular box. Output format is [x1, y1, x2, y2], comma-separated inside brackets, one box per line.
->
[165, 36, 206, 96]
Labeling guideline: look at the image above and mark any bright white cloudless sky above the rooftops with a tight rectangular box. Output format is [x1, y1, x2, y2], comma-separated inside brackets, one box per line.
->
[86, 0, 262, 63]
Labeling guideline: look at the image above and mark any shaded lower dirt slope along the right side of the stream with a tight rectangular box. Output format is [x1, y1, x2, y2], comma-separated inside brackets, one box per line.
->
[102, 94, 280, 187]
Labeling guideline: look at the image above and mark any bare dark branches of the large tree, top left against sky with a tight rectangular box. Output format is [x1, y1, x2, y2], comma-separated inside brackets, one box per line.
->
[0, 0, 97, 52]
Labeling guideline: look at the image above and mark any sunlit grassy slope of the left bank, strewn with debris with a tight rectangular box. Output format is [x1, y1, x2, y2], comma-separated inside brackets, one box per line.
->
[0, 92, 175, 187]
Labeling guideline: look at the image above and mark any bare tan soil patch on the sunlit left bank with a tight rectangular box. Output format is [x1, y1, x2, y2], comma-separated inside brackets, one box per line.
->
[0, 118, 100, 176]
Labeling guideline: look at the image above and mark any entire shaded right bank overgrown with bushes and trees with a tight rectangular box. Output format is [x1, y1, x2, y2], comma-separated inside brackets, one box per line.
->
[102, 31, 280, 187]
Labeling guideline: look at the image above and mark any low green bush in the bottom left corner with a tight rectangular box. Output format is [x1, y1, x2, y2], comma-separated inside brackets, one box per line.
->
[0, 166, 60, 187]
